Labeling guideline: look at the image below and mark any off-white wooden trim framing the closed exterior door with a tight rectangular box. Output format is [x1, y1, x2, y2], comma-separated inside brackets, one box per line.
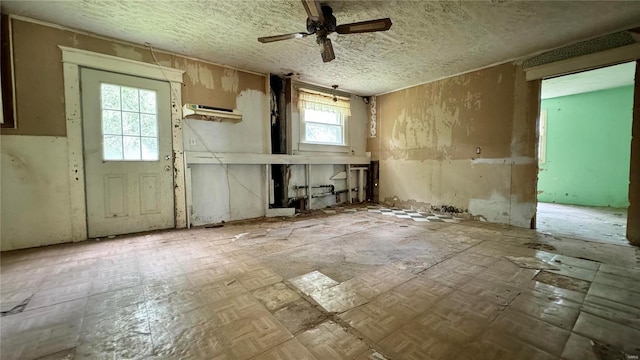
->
[58, 46, 187, 241]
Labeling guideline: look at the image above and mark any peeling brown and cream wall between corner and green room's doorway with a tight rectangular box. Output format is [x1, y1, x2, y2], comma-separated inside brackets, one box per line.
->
[367, 64, 539, 227]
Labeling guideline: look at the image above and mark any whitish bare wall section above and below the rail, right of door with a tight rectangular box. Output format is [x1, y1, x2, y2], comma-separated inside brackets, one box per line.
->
[183, 88, 270, 225]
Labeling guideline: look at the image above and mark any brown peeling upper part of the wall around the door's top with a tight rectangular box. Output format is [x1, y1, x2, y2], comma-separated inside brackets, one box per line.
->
[2, 19, 265, 136]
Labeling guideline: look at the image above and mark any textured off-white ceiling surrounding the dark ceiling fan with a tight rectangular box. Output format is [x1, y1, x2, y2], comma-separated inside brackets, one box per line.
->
[2, 0, 640, 95]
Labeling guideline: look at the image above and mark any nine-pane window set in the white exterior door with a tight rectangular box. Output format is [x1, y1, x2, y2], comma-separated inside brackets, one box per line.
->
[100, 83, 158, 161]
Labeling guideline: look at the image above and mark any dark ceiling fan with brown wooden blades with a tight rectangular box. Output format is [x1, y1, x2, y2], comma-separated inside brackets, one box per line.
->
[258, 0, 391, 62]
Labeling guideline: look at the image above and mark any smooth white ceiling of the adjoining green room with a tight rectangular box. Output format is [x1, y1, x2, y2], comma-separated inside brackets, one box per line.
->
[542, 62, 636, 99]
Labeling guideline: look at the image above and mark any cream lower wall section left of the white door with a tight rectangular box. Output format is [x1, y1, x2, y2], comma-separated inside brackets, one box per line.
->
[0, 135, 72, 251]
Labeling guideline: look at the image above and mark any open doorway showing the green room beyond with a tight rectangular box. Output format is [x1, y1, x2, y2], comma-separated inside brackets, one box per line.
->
[536, 62, 636, 245]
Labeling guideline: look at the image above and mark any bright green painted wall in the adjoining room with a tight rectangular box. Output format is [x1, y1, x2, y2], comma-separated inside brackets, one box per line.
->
[538, 86, 633, 207]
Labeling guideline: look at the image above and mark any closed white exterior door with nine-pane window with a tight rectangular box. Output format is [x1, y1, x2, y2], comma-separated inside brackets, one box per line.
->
[80, 68, 175, 238]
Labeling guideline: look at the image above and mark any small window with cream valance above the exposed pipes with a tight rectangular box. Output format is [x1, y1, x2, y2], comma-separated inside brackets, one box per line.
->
[298, 89, 351, 146]
